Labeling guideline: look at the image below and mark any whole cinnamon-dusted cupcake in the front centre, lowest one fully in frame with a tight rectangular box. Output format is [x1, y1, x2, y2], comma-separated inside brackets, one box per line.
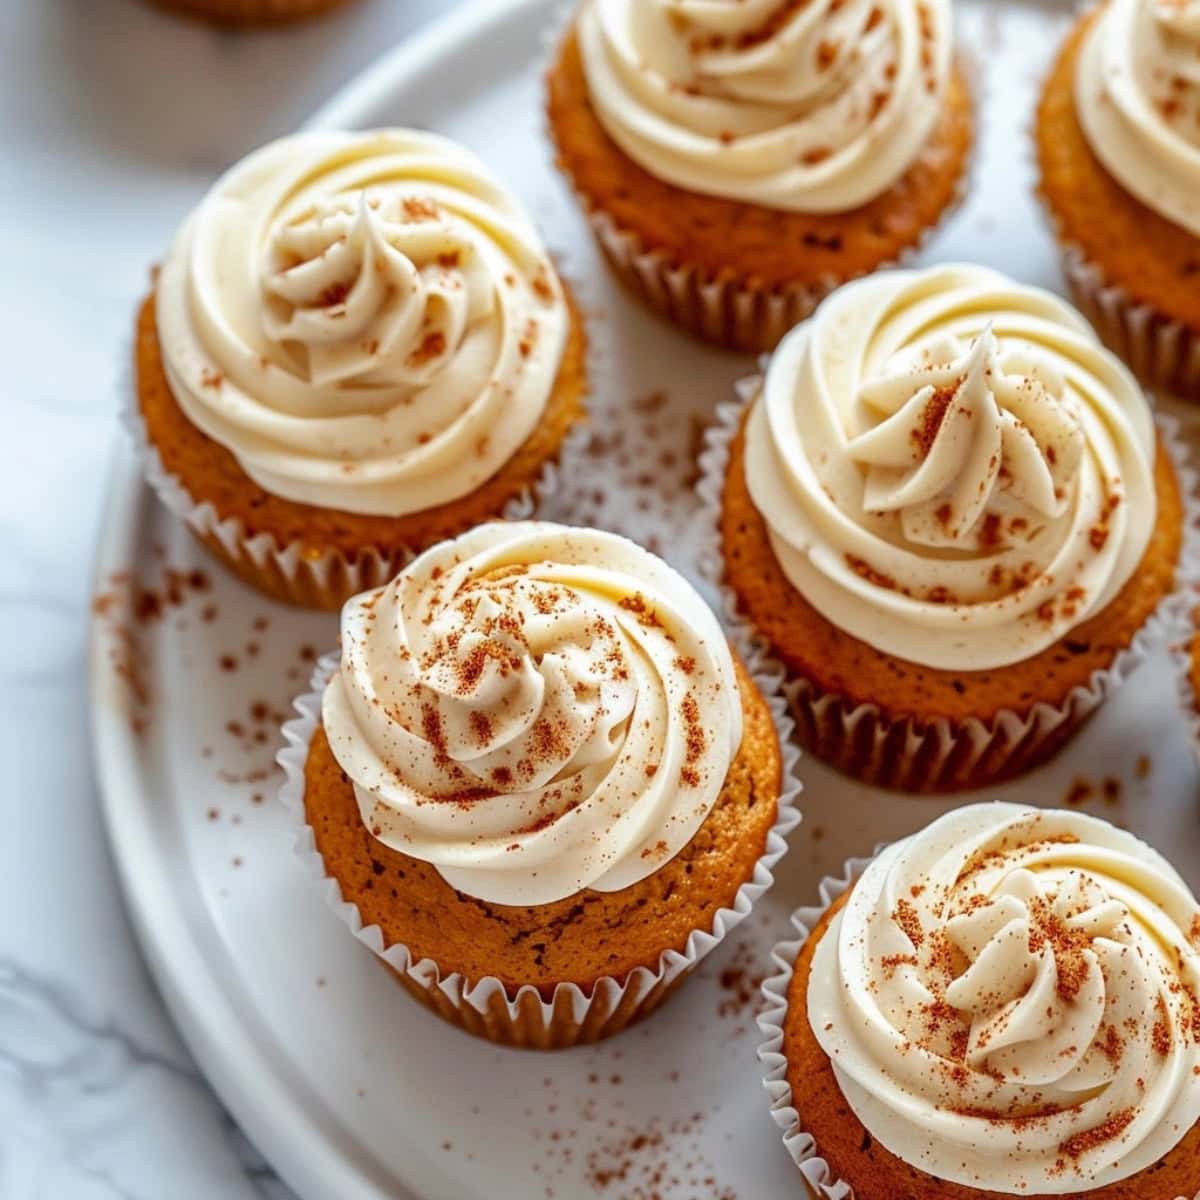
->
[280, 522, 796, 1048]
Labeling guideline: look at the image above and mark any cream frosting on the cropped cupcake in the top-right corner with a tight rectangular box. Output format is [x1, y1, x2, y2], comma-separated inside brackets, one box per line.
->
[1075, 0, 1200, 236]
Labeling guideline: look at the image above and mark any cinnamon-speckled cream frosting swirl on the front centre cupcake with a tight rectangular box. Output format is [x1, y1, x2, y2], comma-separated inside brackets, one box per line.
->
[322, 522, 742, 905]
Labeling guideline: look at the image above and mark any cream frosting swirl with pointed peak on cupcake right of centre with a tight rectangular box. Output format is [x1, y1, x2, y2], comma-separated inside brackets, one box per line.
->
[745, 266, 1156, 670]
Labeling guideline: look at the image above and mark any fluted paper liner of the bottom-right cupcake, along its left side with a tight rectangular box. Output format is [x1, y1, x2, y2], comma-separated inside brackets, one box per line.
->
[758, 846, 1200, 1200]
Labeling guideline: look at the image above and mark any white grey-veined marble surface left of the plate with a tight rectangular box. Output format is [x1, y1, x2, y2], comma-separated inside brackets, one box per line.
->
[0, 0, 454, 1200]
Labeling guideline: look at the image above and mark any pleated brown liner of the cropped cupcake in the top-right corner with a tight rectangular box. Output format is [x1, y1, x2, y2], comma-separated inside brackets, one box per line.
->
[1052, 248, 1200, 400]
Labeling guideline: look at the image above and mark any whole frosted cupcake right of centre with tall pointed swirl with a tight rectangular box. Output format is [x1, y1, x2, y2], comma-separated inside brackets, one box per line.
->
[702, 266, 1184, 791]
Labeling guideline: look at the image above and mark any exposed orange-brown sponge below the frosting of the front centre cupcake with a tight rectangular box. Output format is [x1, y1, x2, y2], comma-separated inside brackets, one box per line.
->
[305, 661, 782, 1000]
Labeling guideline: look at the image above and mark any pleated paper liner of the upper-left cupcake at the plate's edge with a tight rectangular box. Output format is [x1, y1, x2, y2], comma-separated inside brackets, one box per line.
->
[120, 314, 595, 610]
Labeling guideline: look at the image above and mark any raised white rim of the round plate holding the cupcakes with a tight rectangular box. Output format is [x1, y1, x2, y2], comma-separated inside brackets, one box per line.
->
[86, 0, 556, 1200]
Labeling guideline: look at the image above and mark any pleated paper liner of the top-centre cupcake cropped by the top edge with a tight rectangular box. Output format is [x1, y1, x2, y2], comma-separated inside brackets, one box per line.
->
[544, 6, 979, 354]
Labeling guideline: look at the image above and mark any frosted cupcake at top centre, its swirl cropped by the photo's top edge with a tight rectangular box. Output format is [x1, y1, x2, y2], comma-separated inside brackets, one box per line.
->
[547, 0, 973, 350]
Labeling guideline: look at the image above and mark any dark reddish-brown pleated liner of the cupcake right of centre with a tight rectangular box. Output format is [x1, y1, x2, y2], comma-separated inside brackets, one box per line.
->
[697, 376, 1200, 792]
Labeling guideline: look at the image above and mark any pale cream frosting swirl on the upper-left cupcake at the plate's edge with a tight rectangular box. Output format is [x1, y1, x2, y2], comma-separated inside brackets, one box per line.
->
[156, 130, 570, 516]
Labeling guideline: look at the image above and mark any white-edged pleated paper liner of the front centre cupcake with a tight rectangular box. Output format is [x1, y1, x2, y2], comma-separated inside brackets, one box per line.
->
[277, 653, 800, 1050]
